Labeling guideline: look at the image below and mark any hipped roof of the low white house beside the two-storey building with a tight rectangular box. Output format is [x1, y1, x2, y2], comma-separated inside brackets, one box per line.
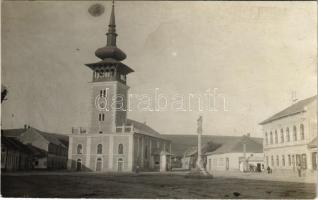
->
[207, 136, 263, 155]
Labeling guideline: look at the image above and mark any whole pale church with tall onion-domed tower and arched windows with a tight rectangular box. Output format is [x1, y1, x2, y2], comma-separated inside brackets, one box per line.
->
[68, 2, 171, 172]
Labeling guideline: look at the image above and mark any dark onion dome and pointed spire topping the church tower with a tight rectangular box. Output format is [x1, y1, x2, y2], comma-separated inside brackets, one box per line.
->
[95, 1, 127, 61]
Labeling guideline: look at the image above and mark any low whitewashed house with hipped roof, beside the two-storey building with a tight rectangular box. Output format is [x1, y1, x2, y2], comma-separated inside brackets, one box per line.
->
[206, 135, 264, 172]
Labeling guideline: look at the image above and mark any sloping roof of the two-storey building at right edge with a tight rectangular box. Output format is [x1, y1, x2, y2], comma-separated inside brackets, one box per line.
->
[260, 95, 317, 125]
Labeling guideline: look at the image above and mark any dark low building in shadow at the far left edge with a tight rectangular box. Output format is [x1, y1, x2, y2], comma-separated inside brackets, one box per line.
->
[1, 136, 33, 171]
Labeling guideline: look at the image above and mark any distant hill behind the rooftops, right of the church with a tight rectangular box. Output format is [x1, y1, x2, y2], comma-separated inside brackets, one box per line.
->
[164, 135, 263, 156]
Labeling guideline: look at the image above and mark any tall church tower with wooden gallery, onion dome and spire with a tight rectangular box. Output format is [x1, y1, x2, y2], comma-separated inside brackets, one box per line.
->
[86, 2, 133, 134]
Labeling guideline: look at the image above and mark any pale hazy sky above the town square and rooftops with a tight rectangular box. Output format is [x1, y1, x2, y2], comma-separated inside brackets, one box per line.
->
[1, 1, 317, 137]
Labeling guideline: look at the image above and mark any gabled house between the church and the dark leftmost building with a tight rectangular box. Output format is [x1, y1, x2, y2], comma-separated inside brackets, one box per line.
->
[2, 125, 68, 169]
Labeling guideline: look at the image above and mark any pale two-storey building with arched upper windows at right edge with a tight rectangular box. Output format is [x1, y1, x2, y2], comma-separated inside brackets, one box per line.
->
[260, 96, 317, 171]
